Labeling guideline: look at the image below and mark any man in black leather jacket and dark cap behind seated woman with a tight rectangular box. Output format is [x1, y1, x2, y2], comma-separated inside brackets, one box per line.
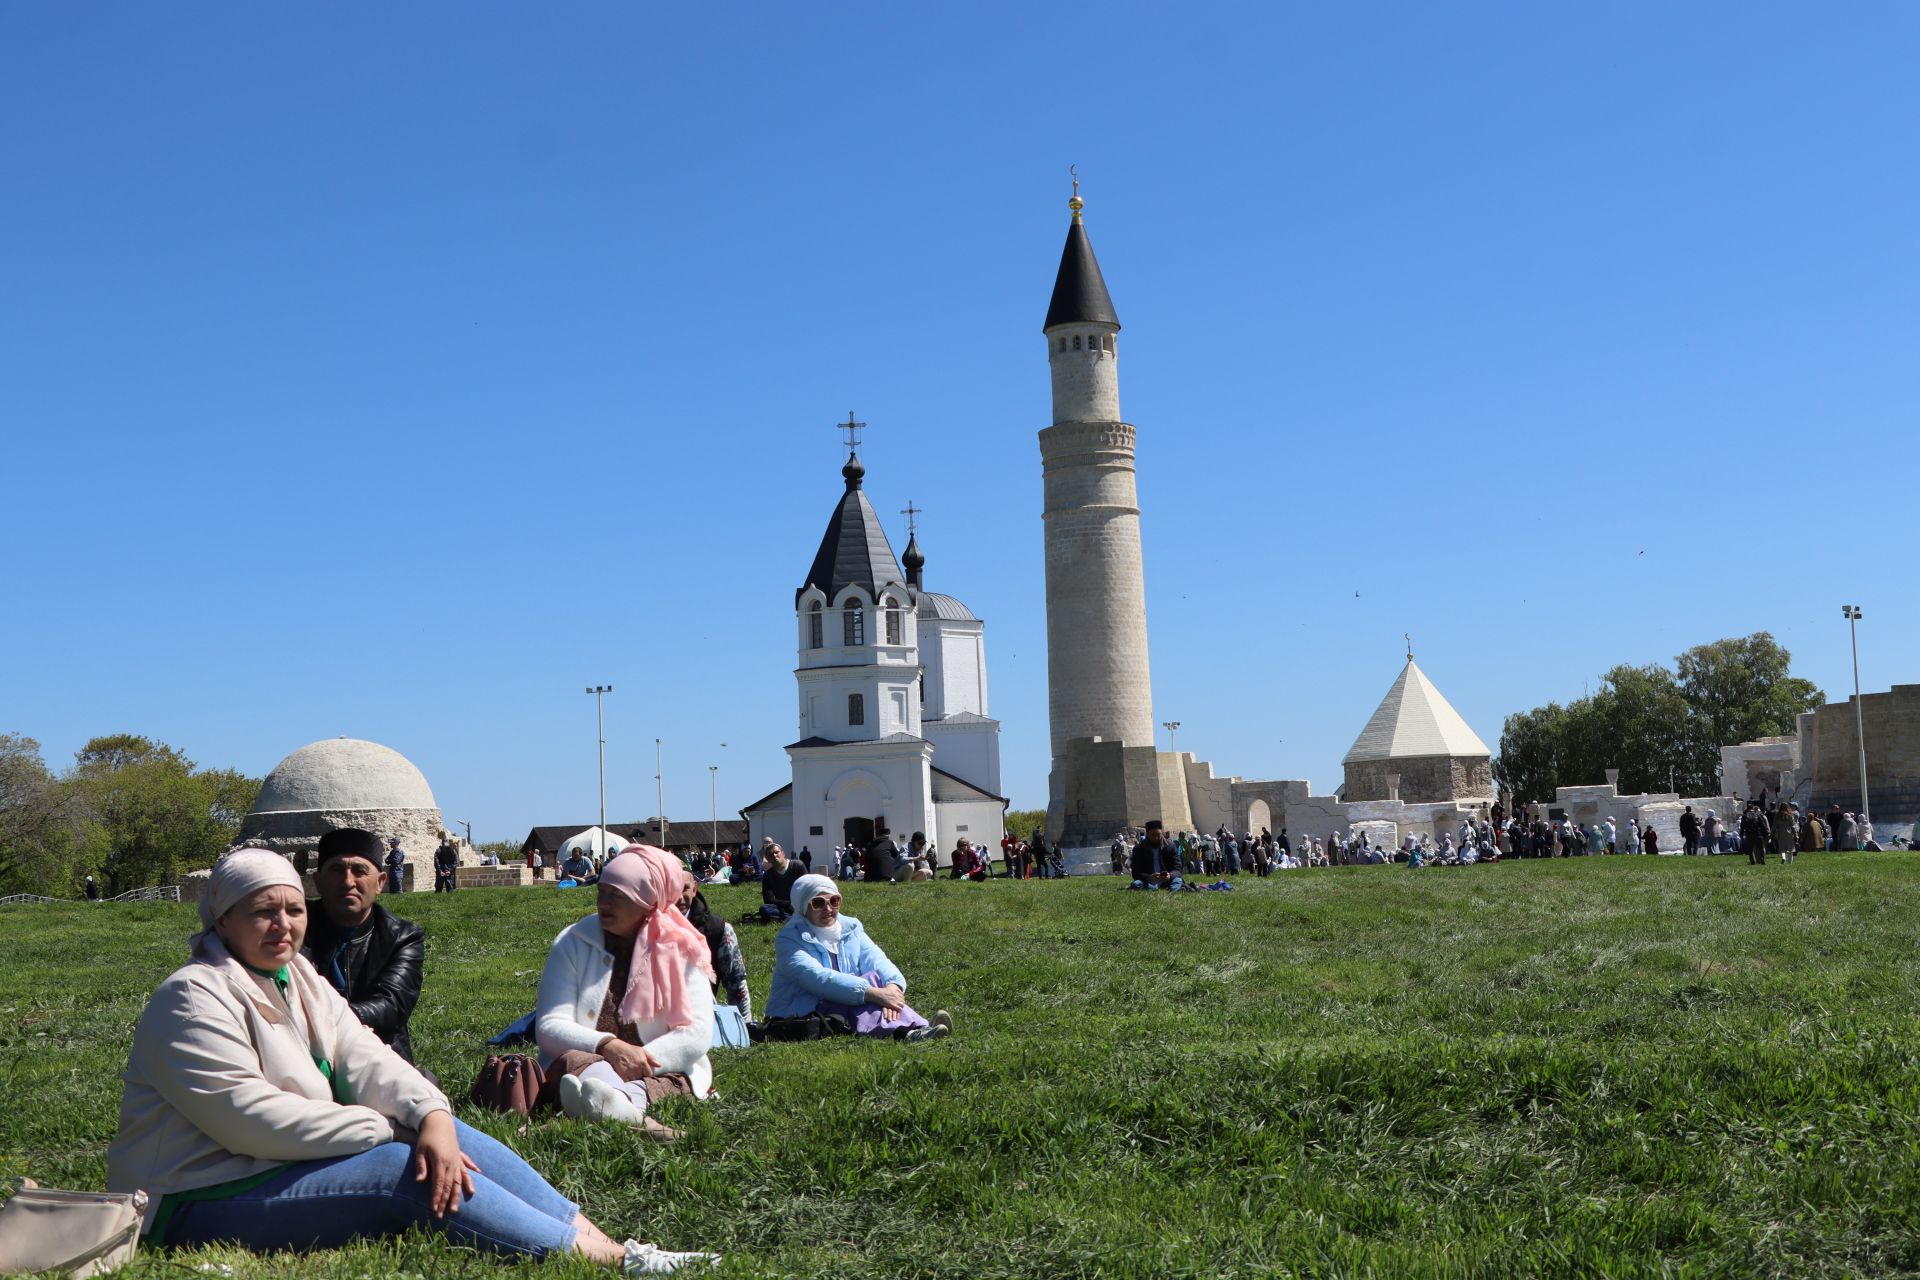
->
[301, 827, 426, 1061]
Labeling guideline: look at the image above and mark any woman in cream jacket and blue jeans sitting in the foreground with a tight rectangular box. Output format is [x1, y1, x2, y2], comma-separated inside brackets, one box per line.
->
[108, 848, 714, 1274]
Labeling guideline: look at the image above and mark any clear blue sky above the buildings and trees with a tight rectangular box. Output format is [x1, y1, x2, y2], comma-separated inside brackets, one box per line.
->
[0, 2, 1920, 839]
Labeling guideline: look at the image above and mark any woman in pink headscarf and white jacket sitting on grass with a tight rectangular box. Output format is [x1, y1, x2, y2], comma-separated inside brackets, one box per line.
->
[534, 844, 714, 1142]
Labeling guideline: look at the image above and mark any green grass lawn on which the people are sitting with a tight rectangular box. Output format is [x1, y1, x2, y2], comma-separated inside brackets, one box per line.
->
[0, 854, 1920, 1280]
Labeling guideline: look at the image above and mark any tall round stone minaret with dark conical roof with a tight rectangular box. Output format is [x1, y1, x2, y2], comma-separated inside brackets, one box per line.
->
[1041, 182, 1159, 839]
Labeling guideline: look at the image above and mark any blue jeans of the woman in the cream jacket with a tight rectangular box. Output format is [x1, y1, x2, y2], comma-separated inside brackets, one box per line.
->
[169, 1121, 580, 1257]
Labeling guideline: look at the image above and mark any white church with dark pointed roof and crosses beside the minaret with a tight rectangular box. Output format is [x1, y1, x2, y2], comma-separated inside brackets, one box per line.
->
[741, 451, 1006, 867]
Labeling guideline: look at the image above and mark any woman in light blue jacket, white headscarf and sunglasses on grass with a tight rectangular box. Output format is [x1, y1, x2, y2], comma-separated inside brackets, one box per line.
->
[766, 875, 954, 1040]
